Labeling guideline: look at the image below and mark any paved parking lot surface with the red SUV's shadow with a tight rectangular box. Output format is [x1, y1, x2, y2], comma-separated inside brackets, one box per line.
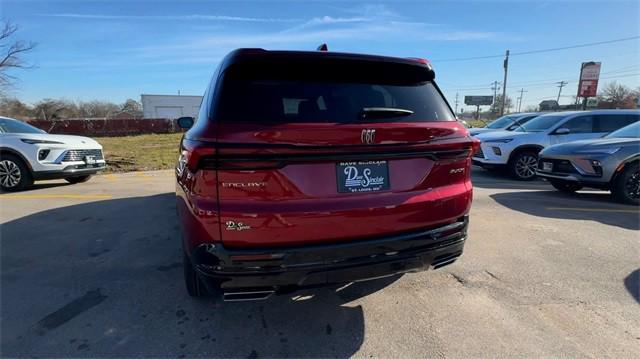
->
[0, 169, 640, 358]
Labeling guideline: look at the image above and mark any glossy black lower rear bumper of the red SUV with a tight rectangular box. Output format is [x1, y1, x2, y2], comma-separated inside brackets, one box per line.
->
[191, 216, 468, 292]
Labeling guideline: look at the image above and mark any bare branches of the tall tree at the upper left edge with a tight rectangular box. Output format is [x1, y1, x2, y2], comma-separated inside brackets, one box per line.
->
[0, 21, 36, 89]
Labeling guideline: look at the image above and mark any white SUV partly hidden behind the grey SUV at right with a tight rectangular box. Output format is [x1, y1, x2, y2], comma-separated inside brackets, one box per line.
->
[473, 110, 640, 180]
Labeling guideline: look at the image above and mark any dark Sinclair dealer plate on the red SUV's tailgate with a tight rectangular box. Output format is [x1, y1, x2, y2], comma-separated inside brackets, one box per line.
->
[336, 161, 391, 193]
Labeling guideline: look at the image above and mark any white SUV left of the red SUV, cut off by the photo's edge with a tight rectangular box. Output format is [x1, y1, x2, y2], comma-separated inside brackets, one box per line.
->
[0, 117, 106, 191]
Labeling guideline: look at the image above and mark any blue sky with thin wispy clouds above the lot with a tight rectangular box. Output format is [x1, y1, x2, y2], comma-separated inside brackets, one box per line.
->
[0, 0, 640, 111]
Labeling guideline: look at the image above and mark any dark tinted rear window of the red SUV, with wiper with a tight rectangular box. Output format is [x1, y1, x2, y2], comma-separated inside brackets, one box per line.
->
[215, 60, 455, 124]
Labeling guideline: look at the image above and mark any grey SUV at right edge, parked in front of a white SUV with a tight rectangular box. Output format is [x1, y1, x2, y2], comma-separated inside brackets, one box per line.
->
[536, 122, 640, 205]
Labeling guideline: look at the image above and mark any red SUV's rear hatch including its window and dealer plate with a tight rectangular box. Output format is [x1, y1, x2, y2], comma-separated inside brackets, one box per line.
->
[210, 54, 472, 248]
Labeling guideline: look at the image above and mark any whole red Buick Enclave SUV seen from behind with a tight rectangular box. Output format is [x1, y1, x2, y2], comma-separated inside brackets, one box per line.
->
[176, 49, 477, 300]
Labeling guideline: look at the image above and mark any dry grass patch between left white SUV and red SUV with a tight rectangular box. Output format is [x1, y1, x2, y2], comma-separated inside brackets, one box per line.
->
[96, 133, 182, 172]
